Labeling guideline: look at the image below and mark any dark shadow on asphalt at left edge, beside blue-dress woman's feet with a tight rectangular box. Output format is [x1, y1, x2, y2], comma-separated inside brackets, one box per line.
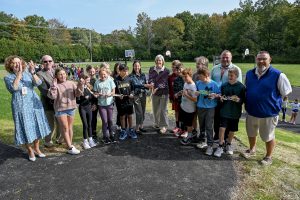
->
[0, 142, 26, 165]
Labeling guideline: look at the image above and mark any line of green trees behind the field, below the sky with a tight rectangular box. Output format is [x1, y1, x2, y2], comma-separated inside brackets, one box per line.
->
[0, 0, 300, 63]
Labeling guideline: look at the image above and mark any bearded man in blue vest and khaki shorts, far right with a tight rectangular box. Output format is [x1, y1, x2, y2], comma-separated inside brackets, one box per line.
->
[243, 51, 292, 165]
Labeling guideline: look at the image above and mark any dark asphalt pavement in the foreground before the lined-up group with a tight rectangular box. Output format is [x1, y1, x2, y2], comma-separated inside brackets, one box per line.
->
[0, 115, 239, 200]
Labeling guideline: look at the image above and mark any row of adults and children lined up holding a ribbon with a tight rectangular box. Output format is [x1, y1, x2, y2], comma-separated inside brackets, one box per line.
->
[5, 50, 292, 165]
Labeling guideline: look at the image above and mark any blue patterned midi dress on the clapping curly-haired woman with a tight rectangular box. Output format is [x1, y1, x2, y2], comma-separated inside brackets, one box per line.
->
[4, 71, 51, 145]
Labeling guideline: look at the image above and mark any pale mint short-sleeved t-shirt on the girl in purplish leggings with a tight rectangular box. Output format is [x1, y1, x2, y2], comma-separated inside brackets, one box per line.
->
[94, 78, 116, 106]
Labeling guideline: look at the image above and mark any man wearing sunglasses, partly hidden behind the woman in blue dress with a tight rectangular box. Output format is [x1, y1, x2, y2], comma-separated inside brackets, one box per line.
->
[37, 55, 60, 147]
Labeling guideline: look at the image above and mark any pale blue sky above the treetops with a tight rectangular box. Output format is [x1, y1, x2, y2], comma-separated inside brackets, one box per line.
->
[0, 0, 293, 34]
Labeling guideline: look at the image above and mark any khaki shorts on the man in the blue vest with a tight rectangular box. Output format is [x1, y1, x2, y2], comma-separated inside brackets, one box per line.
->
[246, 115, 279, 142]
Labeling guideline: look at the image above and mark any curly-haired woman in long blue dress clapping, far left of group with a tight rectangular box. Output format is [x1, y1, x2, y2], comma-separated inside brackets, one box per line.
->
[4, 56, 51, 161]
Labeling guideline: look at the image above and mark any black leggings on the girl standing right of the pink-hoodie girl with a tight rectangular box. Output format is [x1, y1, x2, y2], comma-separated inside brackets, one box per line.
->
[79, 105, 92, 139]
